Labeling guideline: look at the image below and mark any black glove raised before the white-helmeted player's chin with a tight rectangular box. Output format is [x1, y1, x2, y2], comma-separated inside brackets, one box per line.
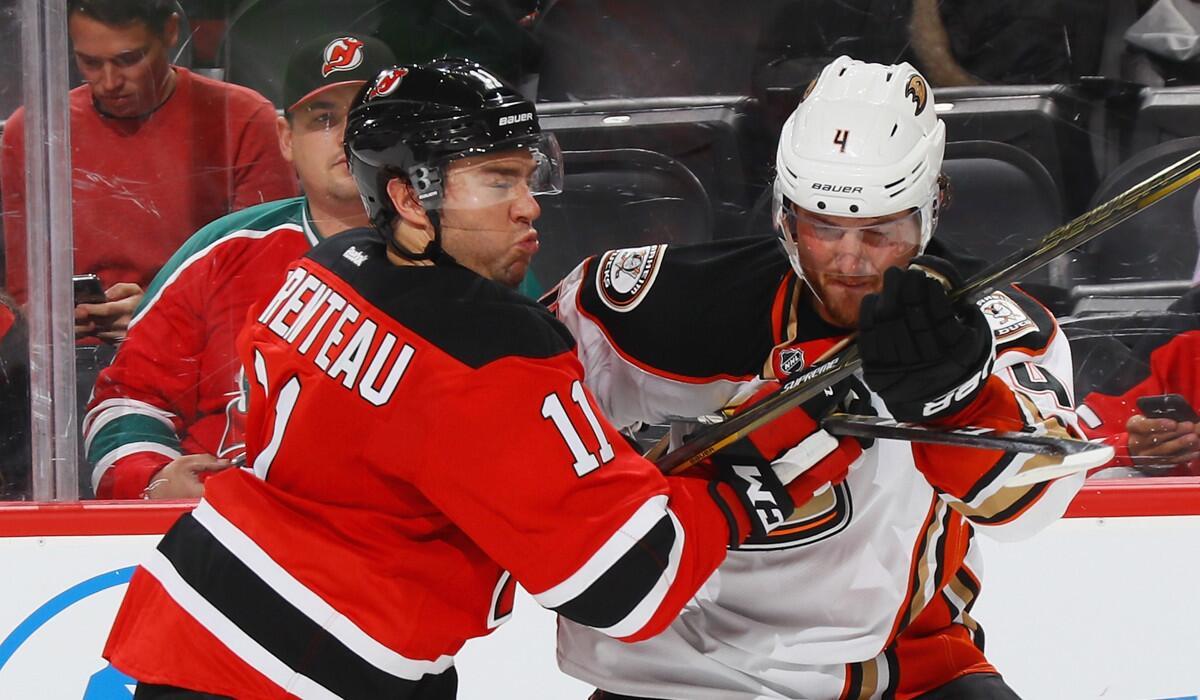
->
[858, 256, 995, 423]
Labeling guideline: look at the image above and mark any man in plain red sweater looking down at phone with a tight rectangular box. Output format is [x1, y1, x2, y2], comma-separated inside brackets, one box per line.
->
[0, 0, 296, 341]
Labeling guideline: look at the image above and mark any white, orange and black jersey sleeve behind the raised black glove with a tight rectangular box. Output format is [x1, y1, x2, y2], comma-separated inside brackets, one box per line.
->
[913, 288, 1085, 539]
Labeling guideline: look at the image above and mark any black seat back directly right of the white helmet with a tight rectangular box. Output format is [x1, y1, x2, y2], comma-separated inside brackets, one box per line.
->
[936, 140, 1069, 287]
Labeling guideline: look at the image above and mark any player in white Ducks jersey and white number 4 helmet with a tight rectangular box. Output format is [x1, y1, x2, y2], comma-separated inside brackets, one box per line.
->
[548, 56, 1084, 700]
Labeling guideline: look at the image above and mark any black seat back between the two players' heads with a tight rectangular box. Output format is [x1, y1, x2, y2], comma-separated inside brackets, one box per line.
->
[533, 149, 713, 288]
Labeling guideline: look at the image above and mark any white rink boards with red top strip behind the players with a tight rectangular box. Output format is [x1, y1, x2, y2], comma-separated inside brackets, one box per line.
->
[0, 479, 1200, 700]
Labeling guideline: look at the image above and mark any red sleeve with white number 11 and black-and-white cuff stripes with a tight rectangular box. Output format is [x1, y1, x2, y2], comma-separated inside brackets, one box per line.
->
[398, 353, 749, 641]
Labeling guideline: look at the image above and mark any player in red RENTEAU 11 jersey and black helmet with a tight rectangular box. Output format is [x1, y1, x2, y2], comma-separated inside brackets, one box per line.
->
[104, 59, 860, 700]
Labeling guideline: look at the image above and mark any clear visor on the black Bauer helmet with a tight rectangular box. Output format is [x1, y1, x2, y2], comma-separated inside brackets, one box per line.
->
[440, 133, 563, 209]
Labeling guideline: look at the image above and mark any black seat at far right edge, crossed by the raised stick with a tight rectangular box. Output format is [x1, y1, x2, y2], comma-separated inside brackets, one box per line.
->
[1074, 136, 1200, 285]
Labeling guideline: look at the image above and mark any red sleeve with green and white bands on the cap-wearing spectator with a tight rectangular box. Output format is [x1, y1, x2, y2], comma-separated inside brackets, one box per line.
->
[83, 238, 223, 498]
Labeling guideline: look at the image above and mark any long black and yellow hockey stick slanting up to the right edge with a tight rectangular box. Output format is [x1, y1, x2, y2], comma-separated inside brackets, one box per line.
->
[656, 151, 1200, 474]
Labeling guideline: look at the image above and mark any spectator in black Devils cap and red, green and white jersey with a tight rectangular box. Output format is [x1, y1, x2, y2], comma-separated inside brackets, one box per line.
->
[84, 34, 395, 498]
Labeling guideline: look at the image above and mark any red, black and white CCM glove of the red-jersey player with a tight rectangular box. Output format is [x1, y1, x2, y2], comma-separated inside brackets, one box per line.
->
[709, 377, 866, 546]
